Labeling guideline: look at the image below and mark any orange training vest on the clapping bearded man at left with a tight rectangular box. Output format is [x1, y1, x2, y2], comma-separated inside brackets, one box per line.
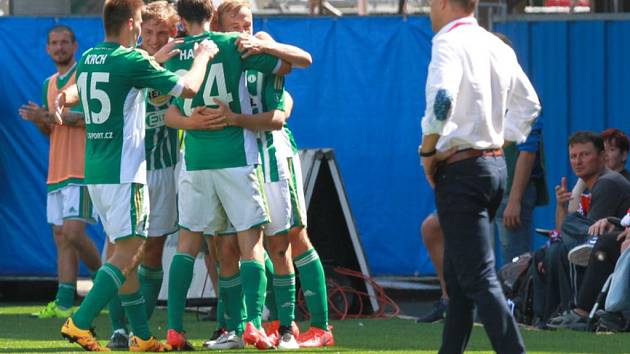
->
[47, 72, 86, 185]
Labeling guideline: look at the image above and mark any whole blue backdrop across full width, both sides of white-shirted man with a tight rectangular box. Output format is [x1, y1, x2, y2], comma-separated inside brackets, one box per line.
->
[0, 17, 630, 276]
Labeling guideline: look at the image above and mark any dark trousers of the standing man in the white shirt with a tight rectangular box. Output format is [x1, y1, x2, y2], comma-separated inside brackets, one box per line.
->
[435, 157, 525, 354]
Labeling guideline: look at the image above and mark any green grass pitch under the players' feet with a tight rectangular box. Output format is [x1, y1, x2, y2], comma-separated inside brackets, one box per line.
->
[0, 304, 630, 353]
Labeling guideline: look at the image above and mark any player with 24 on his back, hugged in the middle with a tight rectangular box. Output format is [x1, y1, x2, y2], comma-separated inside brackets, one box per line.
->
[166, 0, 290, 349]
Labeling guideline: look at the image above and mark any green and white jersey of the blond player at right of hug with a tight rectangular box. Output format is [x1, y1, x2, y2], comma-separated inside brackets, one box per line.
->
[245, 70, 293, 182]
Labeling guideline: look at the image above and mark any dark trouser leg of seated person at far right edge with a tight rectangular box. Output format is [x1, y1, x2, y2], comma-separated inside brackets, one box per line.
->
[577, 231, 622, 311]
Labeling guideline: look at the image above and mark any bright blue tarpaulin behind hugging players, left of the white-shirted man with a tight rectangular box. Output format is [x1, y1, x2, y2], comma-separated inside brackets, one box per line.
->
[0, 17, 433, 275]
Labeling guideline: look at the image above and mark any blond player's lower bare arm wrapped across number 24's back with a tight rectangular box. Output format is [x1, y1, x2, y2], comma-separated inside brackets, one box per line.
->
[204, 98, 287, 131]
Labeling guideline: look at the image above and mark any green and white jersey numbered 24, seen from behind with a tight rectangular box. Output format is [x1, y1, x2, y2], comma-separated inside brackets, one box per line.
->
[166, 32, 281, 171]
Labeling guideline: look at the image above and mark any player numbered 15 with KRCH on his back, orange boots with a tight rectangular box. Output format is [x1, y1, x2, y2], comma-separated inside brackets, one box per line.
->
[56, 0, 217, 352]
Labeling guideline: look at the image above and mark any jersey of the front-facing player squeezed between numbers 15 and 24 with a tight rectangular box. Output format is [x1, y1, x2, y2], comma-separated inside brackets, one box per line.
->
[144, 89, 179, 171]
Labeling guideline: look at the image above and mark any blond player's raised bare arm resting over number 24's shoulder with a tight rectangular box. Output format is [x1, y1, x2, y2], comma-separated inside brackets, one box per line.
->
[237, 32, 313, 68]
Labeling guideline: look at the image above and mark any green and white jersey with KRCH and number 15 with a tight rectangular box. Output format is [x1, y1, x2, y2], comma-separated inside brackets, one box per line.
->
[76, 42, 182, 184]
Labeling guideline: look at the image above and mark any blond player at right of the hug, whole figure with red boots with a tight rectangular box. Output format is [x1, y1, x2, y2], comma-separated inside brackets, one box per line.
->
[199, 0, 334, 349]
